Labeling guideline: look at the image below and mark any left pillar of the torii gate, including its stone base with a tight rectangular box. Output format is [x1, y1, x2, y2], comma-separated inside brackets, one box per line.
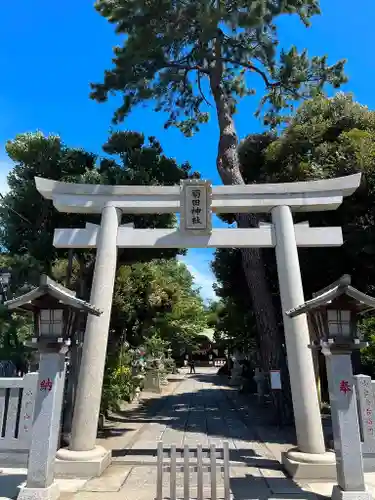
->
[56, 204, 121, 477]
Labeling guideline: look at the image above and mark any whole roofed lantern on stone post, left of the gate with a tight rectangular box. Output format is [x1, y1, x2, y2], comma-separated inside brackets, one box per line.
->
[4, 275, 101, 500]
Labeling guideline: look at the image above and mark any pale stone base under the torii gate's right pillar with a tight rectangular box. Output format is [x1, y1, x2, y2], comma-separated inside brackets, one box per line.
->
[281, 448, 337, 481]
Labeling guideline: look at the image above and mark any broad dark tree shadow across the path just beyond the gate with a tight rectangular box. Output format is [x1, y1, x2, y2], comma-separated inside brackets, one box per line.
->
[100, 373, 302, 456]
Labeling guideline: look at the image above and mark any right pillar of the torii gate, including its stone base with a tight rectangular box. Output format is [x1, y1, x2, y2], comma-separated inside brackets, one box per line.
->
[272, 205, 336, 479]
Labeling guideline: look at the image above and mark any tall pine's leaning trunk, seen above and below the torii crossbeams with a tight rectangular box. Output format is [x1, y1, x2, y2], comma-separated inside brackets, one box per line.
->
[210, 44, 291, 418]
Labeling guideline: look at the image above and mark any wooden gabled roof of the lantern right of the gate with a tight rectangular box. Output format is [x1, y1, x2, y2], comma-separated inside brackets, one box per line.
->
[285, 274, 375, 318]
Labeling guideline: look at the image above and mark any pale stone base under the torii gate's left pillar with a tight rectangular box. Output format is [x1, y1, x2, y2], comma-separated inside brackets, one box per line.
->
[55, 446, 112, 479]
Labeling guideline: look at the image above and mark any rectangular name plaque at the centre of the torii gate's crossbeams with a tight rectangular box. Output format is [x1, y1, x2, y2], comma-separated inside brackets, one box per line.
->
[180, 179, 212, 234]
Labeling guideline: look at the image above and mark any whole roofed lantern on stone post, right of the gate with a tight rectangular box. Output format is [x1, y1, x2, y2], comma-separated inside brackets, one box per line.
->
[286, 275, 375, 500]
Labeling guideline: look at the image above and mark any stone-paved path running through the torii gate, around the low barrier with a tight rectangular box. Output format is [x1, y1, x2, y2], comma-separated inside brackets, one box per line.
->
[60, 368, 324, 500]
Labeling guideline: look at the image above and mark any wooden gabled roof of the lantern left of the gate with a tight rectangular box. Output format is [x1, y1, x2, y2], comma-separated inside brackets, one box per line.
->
[4, 274, 102, 316]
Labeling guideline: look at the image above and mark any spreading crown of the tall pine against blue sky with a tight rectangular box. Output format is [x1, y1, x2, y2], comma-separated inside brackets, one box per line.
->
[91, 0, 346, 131]
